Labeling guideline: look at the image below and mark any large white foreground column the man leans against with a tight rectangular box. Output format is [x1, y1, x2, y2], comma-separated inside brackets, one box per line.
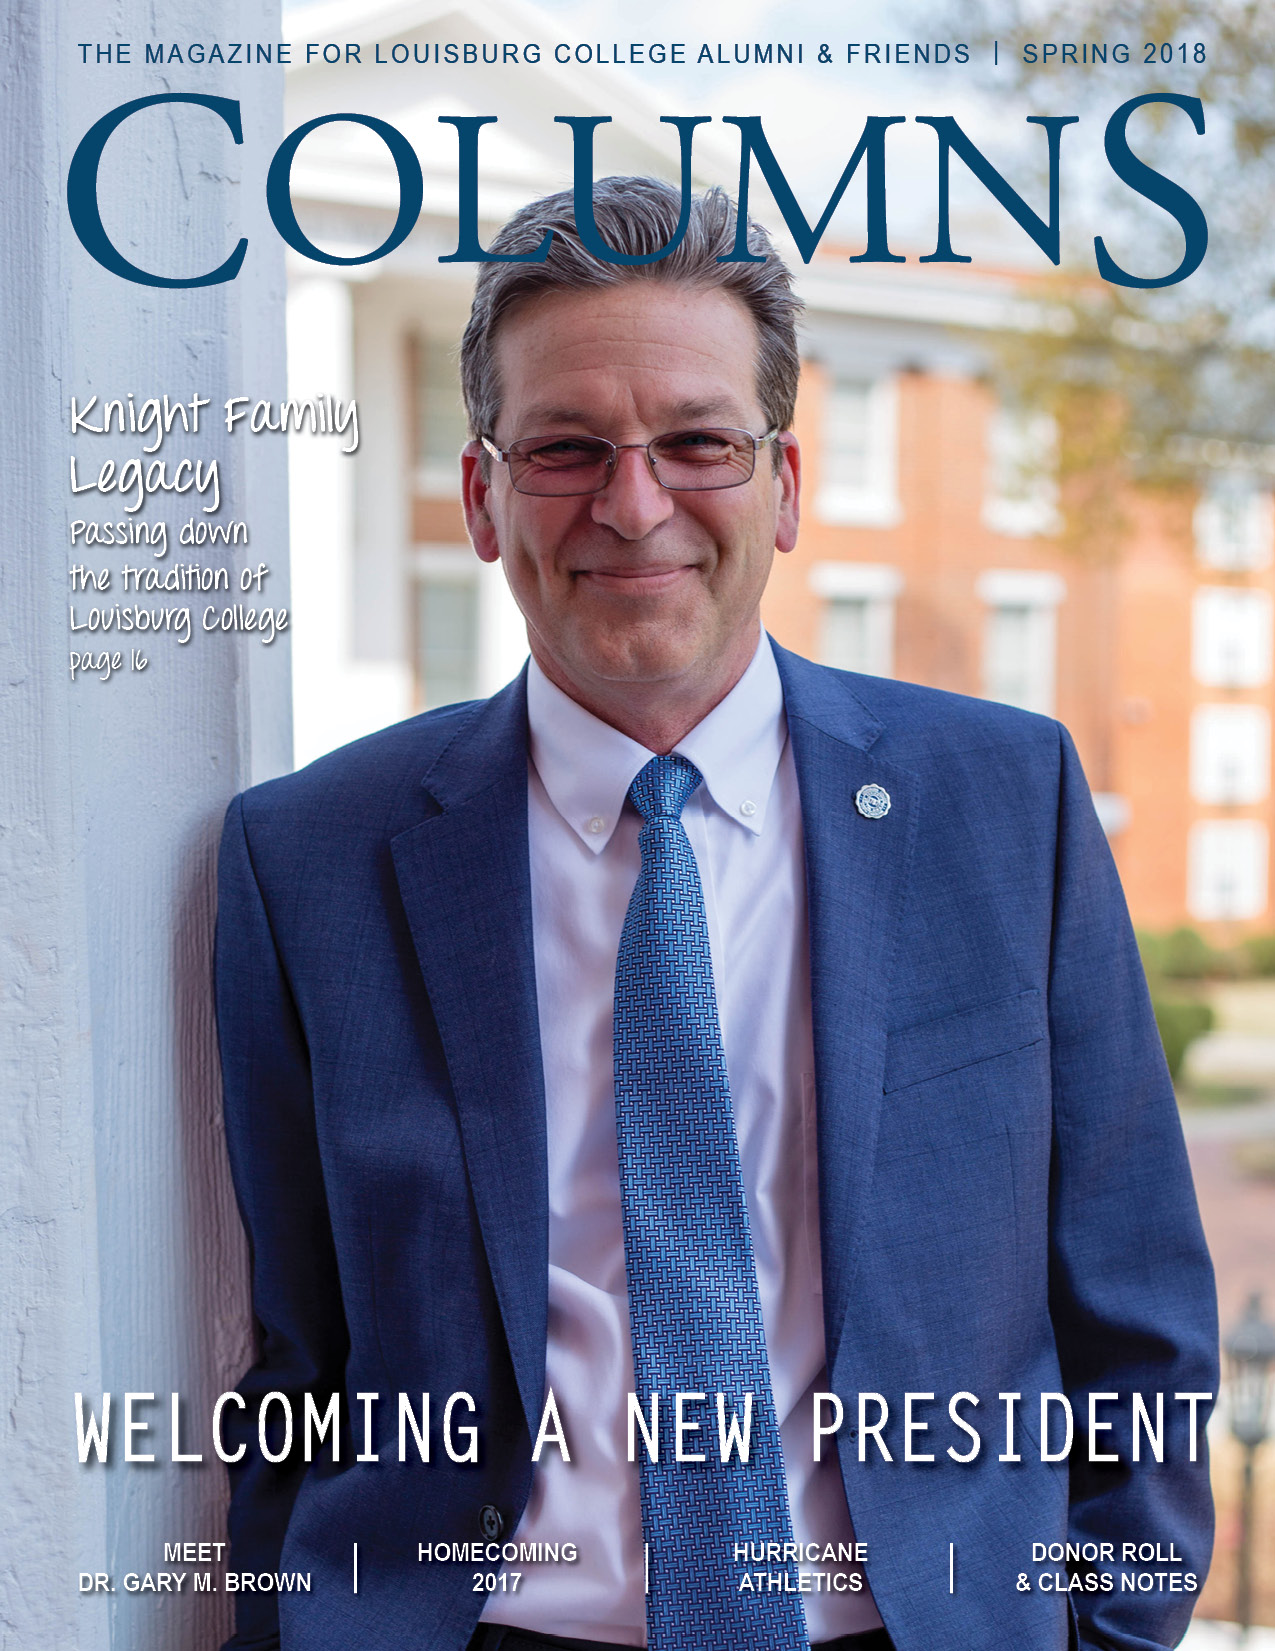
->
[0, 0, 291, 1651]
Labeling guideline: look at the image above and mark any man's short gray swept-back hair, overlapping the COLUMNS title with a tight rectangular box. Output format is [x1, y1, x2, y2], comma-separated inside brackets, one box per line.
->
[461, 177, 801, 439]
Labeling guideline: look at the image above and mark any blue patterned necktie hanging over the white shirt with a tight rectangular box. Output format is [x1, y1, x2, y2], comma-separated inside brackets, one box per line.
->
[614, 755, 809, 1651]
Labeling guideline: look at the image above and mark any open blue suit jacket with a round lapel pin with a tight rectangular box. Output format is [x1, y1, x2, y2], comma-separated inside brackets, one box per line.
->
[218, 650, 1217, 1651]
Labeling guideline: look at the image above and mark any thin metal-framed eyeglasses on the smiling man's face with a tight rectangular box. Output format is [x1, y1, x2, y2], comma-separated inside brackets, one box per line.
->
[482, 429, 780, 499]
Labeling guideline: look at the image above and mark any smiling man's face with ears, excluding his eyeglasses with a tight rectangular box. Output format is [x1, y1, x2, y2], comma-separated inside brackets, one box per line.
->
[462, 281, 799, 705]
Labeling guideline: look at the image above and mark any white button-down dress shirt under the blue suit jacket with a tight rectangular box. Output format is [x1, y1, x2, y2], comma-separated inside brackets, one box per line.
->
[484, 636, 880, 1644]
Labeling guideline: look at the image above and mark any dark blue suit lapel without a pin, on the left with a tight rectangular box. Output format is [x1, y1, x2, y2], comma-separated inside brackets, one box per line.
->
[393, 677, 548, 1435]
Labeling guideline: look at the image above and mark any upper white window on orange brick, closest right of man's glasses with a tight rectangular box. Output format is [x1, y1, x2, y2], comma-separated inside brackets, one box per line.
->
[814, 378, 903, 527]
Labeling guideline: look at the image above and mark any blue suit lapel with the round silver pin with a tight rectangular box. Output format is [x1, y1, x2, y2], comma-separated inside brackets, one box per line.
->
[775, 647, 918, 1370]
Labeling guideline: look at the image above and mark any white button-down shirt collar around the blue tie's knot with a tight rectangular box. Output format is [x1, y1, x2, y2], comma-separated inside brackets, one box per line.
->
[527, 631, 788, 854]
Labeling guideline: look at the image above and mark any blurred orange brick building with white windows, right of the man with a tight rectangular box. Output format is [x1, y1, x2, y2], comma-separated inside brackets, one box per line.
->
[766, 277, 1275, 941]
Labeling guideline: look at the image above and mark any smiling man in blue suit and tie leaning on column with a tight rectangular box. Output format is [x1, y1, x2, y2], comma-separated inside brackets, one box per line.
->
[218, 178, 1216, 1651]
